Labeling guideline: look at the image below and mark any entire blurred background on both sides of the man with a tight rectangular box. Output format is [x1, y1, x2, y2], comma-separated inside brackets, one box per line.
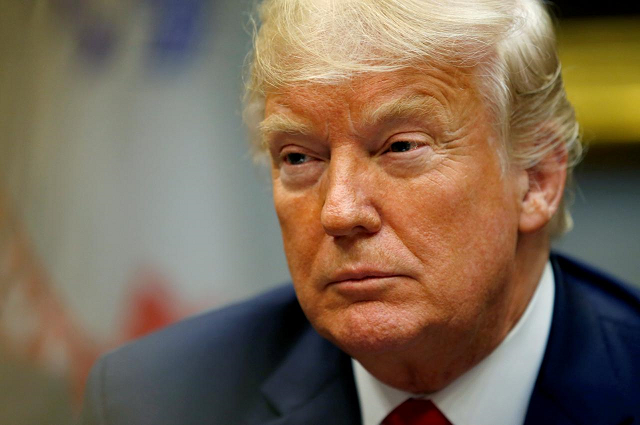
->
[0, 0, 640, 424]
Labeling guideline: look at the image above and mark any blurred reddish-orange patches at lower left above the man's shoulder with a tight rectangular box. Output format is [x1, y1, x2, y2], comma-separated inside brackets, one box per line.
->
[0, 188, 198, 408]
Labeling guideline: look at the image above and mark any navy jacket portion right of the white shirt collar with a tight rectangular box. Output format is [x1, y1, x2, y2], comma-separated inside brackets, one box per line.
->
[525, 254, 640, 425]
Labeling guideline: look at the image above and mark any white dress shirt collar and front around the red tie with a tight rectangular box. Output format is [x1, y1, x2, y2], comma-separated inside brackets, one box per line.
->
[352, 262, 555, 425]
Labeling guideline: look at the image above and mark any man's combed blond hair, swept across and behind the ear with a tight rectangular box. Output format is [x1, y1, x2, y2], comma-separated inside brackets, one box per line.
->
[244, 0, 582, 237]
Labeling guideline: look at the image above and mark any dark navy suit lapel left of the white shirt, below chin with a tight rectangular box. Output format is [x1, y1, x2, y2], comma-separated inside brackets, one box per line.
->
[262, 327, 360, 425]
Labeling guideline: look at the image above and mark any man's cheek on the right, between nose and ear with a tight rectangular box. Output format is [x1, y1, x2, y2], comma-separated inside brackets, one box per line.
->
[388, 161, 518, 302]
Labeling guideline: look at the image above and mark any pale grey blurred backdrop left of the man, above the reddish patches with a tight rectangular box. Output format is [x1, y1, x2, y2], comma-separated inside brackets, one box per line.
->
[1, 0, 287, 337]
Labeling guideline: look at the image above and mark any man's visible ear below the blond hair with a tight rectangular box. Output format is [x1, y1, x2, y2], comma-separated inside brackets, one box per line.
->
[518, 146, 567, 233]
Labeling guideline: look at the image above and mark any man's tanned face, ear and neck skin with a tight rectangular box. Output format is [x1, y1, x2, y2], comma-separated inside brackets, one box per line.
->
[263, 66, 566, 393]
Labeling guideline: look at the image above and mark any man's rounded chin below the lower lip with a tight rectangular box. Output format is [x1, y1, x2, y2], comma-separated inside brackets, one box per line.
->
[312, 302, 424, 357]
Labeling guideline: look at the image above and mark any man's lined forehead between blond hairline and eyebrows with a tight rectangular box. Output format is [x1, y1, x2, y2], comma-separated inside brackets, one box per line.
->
[263, 66, 478, 128]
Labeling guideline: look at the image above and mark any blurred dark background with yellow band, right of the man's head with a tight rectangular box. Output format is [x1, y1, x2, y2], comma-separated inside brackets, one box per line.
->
[555, 14, 640, 285]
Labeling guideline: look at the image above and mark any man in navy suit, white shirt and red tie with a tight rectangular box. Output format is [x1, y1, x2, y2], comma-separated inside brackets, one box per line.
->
[84, 0, 640, 425]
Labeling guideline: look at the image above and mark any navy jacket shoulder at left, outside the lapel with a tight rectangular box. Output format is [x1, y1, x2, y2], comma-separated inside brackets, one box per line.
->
[83, 285, 310, 424]
